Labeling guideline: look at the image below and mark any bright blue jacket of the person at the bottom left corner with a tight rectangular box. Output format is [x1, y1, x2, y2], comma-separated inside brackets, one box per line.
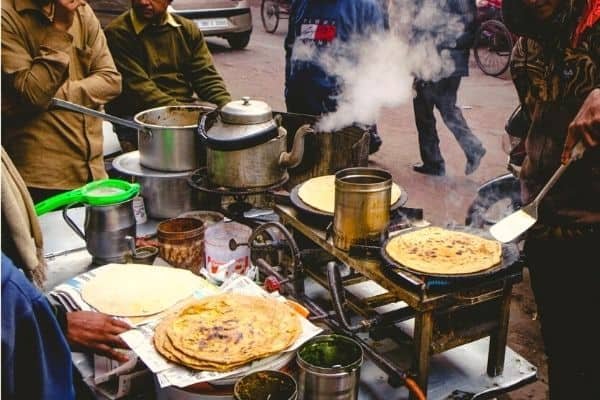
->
[2, 253, 75, 400]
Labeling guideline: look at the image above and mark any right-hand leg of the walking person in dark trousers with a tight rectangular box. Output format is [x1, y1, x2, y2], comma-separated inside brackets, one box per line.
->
[436, 76, 485, 175]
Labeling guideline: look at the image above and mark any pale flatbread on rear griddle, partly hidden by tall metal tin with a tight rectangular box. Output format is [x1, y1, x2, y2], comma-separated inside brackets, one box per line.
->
[298, 175, 401, 214]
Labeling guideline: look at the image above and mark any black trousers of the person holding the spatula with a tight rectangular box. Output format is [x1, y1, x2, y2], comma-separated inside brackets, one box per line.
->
[525, 234, 600, 400]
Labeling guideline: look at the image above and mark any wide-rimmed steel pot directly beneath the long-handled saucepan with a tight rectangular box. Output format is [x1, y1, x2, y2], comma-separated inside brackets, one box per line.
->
[113, 151, 200, 219]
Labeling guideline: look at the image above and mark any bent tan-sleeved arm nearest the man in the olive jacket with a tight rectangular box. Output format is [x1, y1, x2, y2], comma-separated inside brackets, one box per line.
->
[56, 5, 121, 108]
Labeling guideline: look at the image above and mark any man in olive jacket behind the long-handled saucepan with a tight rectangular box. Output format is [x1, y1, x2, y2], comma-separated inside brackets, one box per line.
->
[105, 0, 231, 147]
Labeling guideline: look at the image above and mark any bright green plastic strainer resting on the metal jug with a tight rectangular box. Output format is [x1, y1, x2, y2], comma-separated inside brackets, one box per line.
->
[35, 179, 140, 216]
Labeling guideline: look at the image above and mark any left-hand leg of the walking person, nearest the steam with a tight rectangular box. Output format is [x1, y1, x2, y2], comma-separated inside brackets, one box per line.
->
[413, 82, 445, 175]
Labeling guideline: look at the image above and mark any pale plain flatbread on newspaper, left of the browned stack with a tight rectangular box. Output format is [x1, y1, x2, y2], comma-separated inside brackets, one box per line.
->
[81, 264, 202, 317]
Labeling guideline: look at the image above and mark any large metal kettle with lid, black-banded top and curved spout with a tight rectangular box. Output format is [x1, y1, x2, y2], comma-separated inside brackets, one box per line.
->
[198, 97, 313, 189]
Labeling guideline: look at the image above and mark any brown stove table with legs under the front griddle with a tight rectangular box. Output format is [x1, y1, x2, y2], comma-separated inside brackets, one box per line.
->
[264, 204, 522, 398]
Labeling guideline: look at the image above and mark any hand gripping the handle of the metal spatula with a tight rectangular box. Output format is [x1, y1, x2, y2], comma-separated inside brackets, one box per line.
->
[561, 88, 600, 164]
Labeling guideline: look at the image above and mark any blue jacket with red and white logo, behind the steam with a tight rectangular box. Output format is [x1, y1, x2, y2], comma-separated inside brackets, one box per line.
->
[284, 0, 385, 115]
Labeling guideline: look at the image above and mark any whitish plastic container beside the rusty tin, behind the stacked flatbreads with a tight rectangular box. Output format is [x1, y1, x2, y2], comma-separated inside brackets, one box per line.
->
[205, 222, 252, 282]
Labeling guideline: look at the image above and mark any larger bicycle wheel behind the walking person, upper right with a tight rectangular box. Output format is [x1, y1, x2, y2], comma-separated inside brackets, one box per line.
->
[473, 20, 513, 76]
